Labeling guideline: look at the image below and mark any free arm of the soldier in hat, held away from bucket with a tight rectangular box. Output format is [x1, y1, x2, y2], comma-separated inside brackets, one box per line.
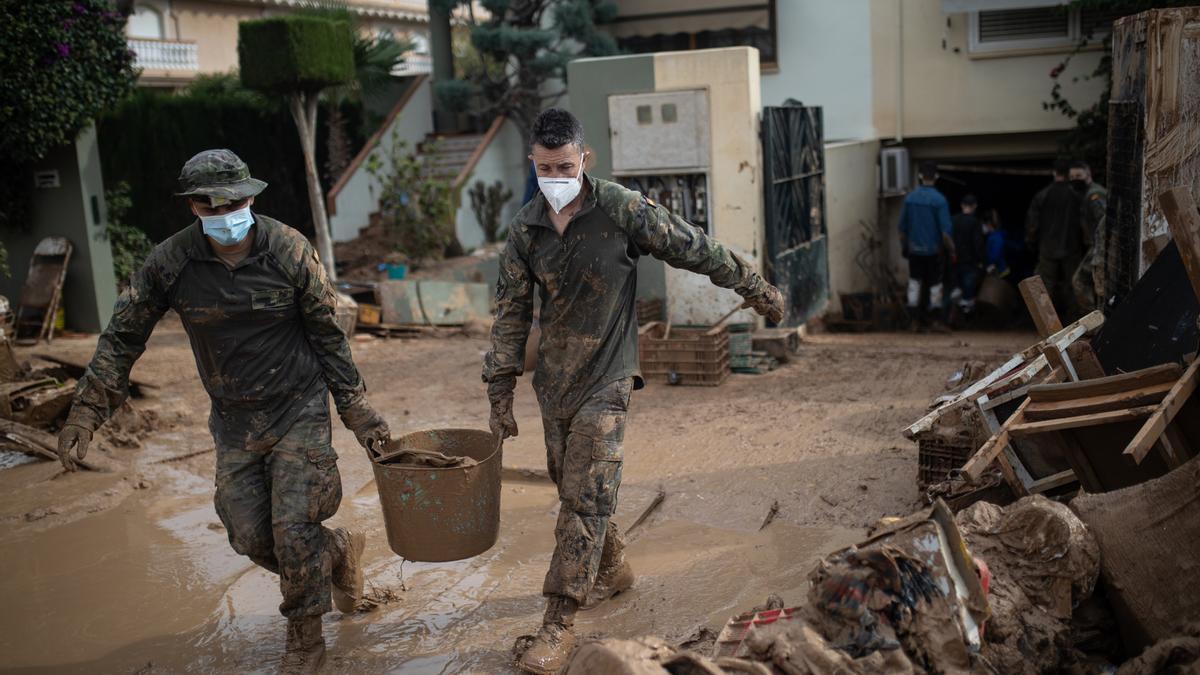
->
[59, 252, 169, 471]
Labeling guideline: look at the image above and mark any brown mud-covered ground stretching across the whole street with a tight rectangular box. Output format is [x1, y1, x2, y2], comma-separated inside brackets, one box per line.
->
[0, 319, 1034, 673]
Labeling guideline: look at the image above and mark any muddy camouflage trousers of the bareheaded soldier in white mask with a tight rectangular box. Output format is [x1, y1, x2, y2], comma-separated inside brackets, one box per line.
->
[541, 377, 634, 604]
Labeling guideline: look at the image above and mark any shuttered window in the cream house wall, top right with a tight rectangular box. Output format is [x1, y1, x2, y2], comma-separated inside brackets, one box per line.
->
[968, 6, 1121, 53]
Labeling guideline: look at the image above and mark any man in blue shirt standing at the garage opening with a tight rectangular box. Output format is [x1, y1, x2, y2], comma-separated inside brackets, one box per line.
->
[900, 162, 955, 330]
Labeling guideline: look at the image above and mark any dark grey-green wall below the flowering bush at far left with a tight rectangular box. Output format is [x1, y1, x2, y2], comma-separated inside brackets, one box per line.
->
[0, 127, 116, 333]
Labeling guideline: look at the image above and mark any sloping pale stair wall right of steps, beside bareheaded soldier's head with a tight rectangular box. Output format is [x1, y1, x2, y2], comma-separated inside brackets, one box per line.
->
[455, 120, 529, 249]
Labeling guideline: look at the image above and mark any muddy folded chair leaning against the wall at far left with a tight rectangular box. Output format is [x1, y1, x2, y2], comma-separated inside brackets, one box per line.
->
[14, 237, 72, 344]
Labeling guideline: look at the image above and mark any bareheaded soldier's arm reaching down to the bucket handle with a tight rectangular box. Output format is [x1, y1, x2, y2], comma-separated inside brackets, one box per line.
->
[484, 234, 533, 438]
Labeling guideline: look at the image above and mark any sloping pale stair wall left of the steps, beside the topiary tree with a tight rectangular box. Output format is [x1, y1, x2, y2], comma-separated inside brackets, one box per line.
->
[328, 77, 433, 241]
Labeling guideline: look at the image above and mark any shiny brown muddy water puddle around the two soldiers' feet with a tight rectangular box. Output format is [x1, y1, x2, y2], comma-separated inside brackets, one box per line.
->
[0, 468, 858, 673]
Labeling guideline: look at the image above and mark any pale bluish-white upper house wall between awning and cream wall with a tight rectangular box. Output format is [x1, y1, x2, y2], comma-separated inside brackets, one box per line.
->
[762, 0, 875, 141]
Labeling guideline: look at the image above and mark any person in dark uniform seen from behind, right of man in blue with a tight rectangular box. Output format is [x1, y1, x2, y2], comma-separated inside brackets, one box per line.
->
[1025, 160, 1084, 322]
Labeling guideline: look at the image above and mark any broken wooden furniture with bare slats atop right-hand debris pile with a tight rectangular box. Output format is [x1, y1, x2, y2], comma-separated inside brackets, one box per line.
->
[962, 359, 1200, 495]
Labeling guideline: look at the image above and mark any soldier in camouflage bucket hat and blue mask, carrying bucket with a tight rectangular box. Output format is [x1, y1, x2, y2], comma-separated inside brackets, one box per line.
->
[59, 150, 389, 673]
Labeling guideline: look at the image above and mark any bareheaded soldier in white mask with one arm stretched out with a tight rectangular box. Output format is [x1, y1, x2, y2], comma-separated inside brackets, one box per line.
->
[484, 108, 784, 674]
